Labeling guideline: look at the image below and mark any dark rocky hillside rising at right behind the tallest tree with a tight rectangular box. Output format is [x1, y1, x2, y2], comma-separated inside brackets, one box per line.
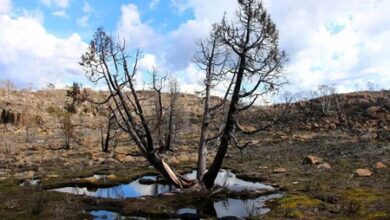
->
[247, 91, 390, 140]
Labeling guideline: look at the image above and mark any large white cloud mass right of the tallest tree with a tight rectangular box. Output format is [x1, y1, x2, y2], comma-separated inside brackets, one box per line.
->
[258, 0, 390, 92]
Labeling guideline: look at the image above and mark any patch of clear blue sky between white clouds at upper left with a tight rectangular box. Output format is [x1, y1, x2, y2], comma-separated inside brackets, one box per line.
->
[13, 0, 193, 41]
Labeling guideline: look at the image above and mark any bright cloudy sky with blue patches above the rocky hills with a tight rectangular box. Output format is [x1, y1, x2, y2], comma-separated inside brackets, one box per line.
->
[0, 0, 390, 95]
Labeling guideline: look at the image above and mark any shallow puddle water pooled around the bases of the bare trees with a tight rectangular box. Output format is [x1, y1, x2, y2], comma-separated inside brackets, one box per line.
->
[52, 170, 283, 220]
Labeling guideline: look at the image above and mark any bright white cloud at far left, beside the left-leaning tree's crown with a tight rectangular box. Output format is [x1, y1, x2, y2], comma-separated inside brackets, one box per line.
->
[0, 15, 87, 87]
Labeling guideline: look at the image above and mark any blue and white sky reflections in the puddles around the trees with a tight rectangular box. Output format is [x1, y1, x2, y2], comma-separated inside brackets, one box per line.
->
[81, 170, 283, 220]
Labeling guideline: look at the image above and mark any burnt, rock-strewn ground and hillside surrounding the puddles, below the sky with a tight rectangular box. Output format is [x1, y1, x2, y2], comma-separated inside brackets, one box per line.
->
[0, 91, 390, 219]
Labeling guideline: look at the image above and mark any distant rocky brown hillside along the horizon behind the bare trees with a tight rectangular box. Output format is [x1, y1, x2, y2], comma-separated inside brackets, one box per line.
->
[0, 90, 390, 138]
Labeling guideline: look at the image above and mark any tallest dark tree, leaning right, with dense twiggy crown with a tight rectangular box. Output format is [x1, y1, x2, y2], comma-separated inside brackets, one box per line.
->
[202, 0, 285, 188]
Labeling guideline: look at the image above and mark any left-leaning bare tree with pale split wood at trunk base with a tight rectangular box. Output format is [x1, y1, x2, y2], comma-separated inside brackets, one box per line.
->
[80, 28, 193, 188]
